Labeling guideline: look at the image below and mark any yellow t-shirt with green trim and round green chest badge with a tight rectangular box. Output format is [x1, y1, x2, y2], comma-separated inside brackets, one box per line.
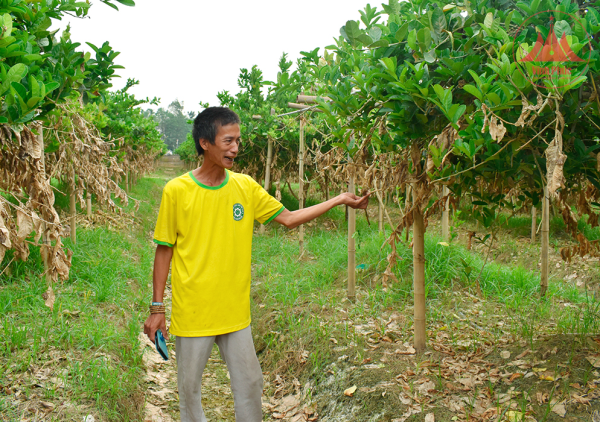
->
[154, 170, 284, 337]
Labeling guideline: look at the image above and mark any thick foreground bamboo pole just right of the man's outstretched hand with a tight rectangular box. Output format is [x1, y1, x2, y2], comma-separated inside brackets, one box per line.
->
[413, 206, 426, 352]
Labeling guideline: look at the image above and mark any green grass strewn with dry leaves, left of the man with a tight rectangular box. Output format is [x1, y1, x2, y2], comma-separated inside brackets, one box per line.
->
[0, 174, 162, 421]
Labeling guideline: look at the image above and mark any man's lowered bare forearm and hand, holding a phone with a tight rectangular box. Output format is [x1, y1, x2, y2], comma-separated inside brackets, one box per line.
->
[144, 245, 173, 343]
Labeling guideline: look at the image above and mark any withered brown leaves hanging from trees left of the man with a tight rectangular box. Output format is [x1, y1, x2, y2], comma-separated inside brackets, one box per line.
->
[0, 104, 154, 281]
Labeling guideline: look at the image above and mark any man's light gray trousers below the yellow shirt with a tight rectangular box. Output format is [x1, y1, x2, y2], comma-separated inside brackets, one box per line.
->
[175, 327, 263, 422]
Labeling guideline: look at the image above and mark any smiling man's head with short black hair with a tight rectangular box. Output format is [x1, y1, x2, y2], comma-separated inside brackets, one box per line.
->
[192, 107, 241, 169]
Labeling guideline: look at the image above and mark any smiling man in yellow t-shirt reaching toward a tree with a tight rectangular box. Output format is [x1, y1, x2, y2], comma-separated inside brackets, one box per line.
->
[144, 107, 369, 422]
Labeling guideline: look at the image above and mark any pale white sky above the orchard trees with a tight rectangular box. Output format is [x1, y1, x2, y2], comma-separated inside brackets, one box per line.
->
[62, 0, 381, 111]
